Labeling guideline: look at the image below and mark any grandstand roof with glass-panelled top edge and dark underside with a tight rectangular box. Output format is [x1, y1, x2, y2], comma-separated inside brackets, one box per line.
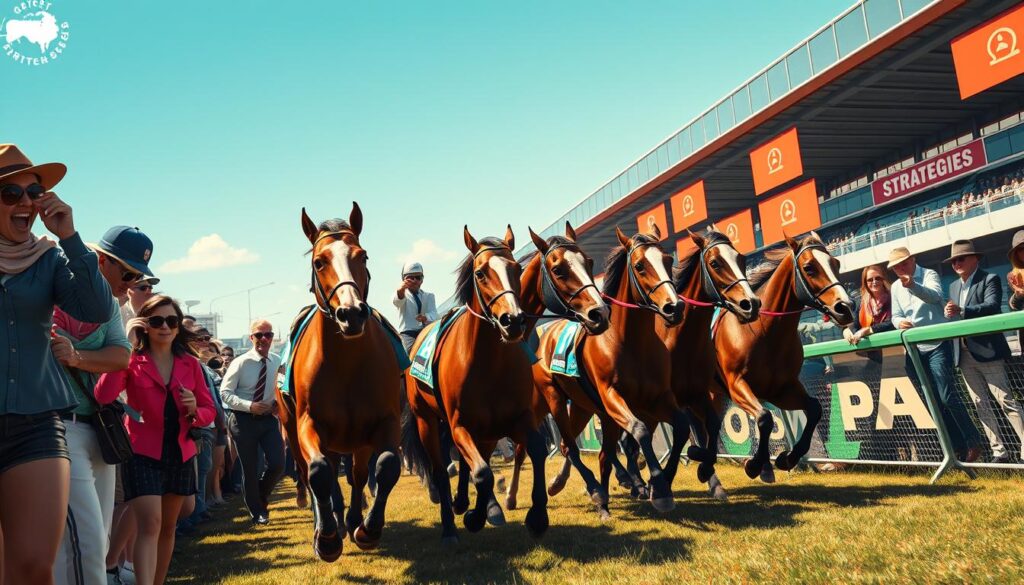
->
[544, 0, 1024, 254]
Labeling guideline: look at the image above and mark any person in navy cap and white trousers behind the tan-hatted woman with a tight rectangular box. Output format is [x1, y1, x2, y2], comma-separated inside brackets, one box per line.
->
[51, 226, 153, 584]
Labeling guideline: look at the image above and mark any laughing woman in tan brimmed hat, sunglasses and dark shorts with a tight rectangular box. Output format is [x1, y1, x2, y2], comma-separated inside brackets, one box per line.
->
[0, 144, 114, 584]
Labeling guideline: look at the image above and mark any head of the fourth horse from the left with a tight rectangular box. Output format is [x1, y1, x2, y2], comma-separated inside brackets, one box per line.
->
[612, 224, 683, 326]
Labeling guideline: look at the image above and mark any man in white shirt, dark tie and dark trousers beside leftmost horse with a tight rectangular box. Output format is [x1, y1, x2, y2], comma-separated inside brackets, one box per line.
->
[220, 320, 285, 525]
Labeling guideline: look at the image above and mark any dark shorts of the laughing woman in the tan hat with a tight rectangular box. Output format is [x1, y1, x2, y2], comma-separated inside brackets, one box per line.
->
[0, 411, 71, 473]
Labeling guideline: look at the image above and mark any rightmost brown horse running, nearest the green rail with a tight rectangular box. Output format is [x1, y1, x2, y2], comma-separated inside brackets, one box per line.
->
[712, 232, 853, 480]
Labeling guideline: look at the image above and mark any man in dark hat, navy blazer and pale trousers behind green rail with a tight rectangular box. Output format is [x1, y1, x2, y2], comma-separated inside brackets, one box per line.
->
[945, 240, 1024, 463]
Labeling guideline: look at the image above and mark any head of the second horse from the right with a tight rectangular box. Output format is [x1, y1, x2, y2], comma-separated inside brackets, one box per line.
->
[690, 228, 761, 323]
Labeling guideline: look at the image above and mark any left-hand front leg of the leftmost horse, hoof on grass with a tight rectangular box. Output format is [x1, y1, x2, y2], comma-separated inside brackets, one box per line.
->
[299, 416, 344, 562]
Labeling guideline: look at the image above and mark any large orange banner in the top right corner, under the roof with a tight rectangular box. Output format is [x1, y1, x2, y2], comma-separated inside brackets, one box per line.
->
[949, 5, 1024, 99]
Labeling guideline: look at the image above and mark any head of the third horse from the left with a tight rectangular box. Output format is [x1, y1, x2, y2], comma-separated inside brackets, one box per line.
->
[529, 221, 611, 335]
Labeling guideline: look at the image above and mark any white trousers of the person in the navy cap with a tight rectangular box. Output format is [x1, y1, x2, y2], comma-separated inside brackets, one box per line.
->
[53, 420, 116, 585]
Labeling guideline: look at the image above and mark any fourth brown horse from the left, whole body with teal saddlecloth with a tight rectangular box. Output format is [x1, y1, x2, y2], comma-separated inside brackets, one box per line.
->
[534, 226, 689, 517]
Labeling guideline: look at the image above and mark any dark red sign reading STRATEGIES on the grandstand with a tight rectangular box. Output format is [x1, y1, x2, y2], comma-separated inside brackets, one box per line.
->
[871, 139, 988, 205]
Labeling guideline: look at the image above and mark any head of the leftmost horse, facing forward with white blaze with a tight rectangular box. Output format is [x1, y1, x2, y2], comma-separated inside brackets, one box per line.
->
[302, 202, 370, 337]
